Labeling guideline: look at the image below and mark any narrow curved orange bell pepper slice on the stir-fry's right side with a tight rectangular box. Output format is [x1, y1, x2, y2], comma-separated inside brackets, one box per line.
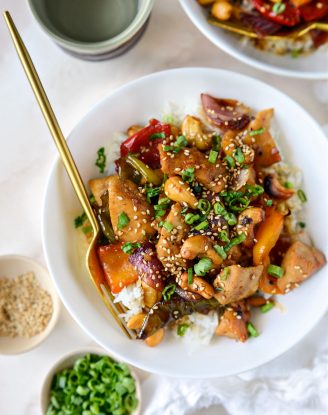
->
[253, 208, 284, 265]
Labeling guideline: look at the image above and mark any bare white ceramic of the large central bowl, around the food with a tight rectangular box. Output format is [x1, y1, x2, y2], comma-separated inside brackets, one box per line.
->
[43, 68, 328, 378]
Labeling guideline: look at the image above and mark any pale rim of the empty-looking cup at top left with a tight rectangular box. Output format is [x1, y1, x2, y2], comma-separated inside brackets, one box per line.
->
[27, 0, 155, 55]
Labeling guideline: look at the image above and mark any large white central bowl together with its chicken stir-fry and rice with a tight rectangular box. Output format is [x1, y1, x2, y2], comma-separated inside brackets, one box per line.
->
[43, 68, 328, 377]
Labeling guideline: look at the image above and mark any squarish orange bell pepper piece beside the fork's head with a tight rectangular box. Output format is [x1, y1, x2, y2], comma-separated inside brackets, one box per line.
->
[98, 243, 138, 294]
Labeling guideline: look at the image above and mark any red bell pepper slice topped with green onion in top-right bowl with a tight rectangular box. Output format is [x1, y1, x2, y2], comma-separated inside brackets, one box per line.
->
[252, 0, 301, 26]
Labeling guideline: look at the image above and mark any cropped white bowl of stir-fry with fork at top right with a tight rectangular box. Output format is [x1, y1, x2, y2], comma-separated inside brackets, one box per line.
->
[180, 0, 328, 79]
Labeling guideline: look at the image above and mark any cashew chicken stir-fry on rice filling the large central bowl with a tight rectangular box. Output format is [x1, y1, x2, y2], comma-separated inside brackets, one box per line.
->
[76, 94, 326, 346]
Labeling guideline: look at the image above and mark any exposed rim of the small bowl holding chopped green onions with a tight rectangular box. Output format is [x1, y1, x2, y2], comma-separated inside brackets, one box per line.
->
[40, 348, 141, 415]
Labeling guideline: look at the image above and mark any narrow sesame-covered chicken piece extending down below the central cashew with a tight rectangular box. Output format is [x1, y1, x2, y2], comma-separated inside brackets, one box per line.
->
[156, 203, 190, 275]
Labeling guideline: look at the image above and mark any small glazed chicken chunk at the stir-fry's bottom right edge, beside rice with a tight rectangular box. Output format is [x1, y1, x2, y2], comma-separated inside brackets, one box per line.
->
[215, 301, 250, 342]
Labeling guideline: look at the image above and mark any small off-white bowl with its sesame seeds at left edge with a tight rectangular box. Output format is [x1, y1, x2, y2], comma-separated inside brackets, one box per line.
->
[0, 255, 60, 355]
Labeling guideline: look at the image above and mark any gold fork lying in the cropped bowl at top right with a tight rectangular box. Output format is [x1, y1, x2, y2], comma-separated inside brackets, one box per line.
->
[208, 17, 328, 40]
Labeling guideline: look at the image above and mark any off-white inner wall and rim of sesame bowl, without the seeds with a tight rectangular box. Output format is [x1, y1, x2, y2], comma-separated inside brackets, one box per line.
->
[0, 255, 60, 355]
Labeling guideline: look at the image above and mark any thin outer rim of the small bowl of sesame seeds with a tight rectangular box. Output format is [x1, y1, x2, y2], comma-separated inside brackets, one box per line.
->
[0, 254, 61, 356]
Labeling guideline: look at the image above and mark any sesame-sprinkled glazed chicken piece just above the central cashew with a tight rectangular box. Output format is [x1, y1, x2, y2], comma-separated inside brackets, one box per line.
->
[158, 145, 227, 193]
